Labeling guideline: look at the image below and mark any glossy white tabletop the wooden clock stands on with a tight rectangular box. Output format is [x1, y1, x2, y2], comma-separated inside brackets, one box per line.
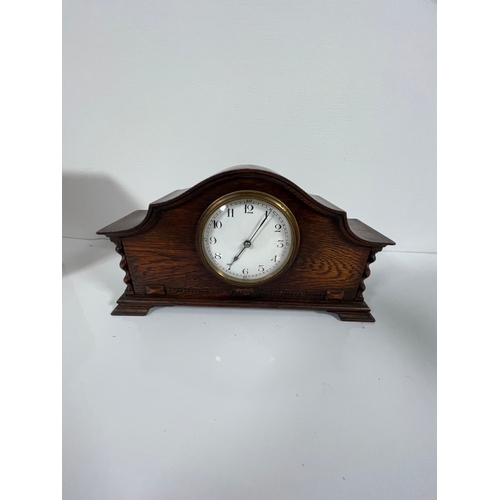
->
[63, 239, 436, 500]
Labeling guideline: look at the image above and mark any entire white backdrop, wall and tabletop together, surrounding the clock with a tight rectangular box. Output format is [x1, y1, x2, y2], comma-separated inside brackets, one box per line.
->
[62, 0, 436, 500]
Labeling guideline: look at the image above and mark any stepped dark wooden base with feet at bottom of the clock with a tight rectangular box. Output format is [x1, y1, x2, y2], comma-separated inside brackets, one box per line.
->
[111, 293, 375, 322]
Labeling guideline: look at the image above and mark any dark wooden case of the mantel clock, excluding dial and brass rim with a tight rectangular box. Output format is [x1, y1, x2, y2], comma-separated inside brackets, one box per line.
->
[97, 165, 395, 321]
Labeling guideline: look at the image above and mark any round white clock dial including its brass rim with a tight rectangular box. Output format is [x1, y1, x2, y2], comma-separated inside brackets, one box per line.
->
[197, 191, 299, 285]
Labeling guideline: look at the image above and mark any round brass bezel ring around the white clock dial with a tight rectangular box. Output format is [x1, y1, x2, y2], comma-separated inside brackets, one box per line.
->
[196, 190, 300, 287]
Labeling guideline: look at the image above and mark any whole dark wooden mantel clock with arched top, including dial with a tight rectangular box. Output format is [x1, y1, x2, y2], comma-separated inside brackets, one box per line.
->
[97, 165, 394, 321]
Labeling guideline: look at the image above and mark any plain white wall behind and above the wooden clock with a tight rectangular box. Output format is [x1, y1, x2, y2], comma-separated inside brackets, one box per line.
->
[63, 0, 438, 251]
